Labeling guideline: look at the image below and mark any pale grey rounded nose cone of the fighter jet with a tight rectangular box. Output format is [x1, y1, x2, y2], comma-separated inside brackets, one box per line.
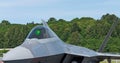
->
[2, 46, 33, 61]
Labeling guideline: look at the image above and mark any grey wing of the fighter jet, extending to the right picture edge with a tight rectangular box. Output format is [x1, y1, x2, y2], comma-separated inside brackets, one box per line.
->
[67, 44, 120, 59]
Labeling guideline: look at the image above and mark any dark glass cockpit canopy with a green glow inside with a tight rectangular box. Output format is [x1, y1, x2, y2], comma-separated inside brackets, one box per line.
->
[27, 26, 52, 39]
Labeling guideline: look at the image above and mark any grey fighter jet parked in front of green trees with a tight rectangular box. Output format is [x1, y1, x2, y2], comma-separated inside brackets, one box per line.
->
[1, 21, 120, 63]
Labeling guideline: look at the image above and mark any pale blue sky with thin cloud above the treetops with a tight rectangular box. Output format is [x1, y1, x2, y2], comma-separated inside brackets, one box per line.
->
[0, 0, 120, 24]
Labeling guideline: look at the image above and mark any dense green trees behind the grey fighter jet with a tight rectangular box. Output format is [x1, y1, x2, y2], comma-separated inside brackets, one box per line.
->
[0, 14, 120, 52]
